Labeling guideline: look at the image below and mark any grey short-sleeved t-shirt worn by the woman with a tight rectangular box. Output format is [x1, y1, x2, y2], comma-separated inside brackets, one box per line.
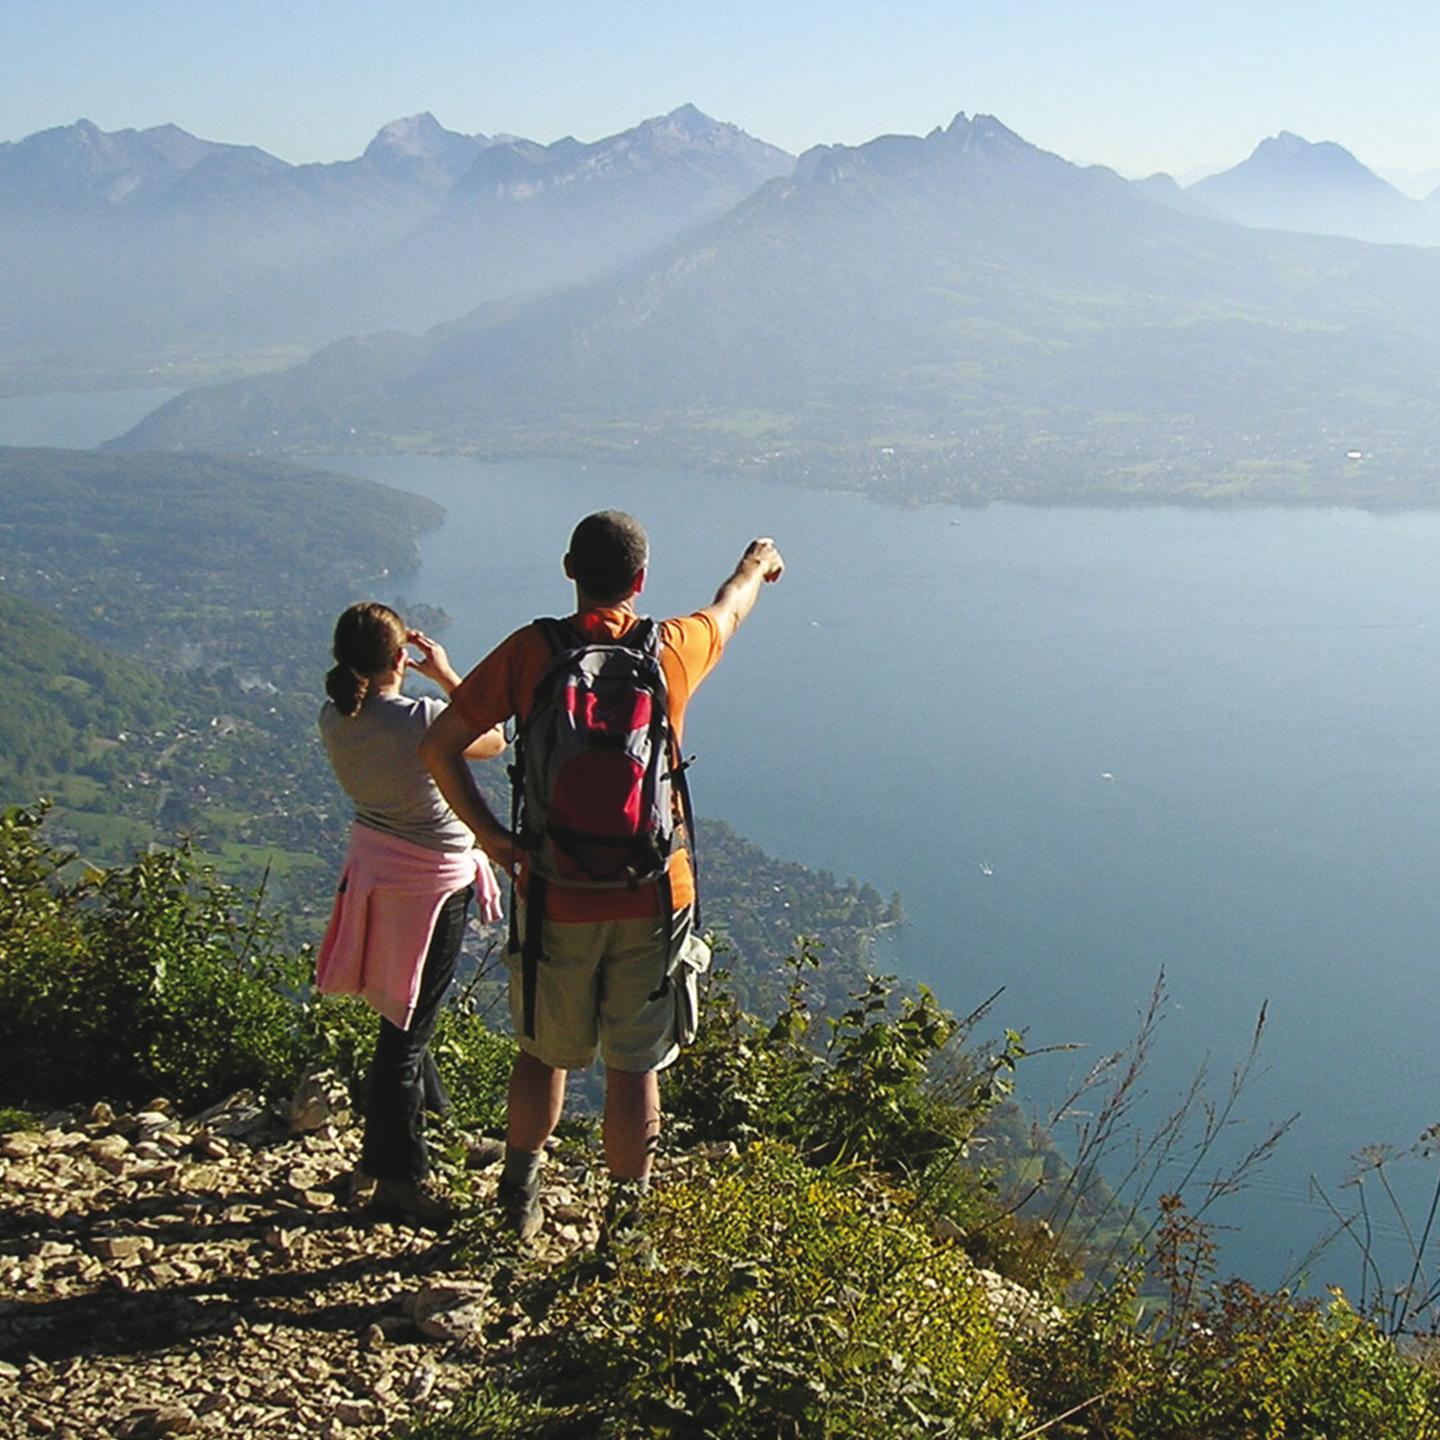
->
[320, 696, 475, 850]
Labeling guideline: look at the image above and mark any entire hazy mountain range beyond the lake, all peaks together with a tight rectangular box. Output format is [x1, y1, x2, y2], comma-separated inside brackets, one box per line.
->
[8, 105, 1440, 503]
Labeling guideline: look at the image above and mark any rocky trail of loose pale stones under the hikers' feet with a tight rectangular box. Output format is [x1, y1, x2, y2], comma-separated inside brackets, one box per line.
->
[0, 1081, 630, 1440]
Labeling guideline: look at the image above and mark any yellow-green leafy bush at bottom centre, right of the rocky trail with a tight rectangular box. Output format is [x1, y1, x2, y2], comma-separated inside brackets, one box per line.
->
[531, 1142, 1027, 1440]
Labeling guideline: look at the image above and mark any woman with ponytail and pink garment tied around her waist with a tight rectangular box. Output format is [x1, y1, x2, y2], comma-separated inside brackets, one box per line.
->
[315, 602, 505, 1228]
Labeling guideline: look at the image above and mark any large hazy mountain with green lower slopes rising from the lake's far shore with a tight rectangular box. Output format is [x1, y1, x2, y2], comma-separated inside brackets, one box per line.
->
[122, 114, 1440, 503]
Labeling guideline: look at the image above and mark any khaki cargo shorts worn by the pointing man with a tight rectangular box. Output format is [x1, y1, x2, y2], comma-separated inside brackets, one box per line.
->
[505, 901, 710, 1073]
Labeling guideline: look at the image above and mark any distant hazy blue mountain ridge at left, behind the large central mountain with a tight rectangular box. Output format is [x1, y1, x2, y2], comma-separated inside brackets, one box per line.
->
[0, 107, 793, 374]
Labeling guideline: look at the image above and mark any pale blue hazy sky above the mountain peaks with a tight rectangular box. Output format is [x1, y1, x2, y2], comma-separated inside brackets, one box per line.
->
[0, 0, 1440, 176]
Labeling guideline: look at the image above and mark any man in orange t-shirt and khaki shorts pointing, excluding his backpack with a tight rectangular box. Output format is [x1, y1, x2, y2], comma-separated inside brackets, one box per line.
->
[420, 510, 785, 1240]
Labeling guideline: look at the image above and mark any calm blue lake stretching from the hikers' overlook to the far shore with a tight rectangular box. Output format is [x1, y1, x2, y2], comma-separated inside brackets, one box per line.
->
[0, 388, 1440, 1283]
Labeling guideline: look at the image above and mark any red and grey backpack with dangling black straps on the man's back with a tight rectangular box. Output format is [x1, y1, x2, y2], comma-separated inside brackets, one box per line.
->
[510, 619, 698, 1037]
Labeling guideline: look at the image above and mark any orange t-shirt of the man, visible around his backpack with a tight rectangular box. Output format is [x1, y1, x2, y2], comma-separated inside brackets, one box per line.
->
[451, 609, 724, 923]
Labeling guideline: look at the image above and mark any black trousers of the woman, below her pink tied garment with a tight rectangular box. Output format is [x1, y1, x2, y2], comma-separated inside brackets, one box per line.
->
[360, 886, 469, 1179]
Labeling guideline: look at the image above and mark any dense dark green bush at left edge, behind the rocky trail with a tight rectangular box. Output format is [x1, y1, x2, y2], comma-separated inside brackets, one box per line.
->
[0, 809, 305, 1102]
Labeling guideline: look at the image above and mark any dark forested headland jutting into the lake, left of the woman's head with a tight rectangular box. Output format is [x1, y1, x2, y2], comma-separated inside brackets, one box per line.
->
[0, 449, 442, 685]
